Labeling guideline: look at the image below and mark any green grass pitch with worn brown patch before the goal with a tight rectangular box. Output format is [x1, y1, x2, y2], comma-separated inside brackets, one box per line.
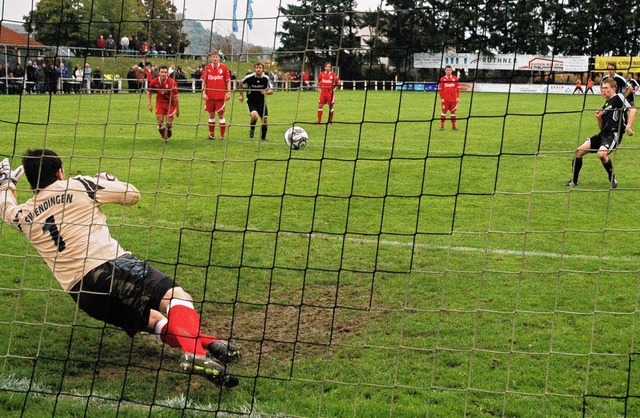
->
[0, 91, 640, 417]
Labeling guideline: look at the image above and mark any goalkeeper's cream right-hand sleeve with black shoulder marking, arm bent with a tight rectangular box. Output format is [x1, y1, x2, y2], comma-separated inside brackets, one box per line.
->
[73, 174, 140, 206]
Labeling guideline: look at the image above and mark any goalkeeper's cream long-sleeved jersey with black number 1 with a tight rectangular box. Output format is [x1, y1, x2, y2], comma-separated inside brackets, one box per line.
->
[0, 175, 140, 291]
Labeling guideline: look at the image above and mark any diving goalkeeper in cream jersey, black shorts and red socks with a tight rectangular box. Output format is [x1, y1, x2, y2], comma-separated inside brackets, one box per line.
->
[0, 149, 240, 387]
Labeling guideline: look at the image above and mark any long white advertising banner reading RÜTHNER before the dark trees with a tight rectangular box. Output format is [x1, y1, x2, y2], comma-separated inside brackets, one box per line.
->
[413, 53, 589, 73]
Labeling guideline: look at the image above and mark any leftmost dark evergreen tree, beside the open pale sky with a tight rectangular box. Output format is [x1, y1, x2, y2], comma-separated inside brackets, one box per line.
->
[277, 0, 363, 78]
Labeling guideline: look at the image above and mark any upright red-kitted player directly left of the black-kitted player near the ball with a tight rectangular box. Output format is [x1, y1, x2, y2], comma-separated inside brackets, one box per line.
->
[201, 51, 231, 141]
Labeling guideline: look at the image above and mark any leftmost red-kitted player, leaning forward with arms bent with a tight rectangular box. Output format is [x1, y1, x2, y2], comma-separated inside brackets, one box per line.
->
[147, 65, 180, 144]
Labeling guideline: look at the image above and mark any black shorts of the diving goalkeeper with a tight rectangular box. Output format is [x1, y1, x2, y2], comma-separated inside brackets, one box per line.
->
[69, 254, 178, 337]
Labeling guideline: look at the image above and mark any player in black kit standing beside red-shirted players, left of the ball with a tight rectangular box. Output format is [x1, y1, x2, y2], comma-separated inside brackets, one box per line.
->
[238, 62, 273, 141]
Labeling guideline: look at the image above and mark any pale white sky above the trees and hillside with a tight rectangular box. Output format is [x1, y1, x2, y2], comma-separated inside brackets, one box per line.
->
[0, 0, 383, 46]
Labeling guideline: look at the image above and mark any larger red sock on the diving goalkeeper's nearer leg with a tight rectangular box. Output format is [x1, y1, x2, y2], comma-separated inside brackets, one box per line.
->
[165, 305, 206, 356]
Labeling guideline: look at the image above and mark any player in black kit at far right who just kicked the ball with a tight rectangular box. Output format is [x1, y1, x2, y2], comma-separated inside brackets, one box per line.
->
[567, 77, 636, 189]
